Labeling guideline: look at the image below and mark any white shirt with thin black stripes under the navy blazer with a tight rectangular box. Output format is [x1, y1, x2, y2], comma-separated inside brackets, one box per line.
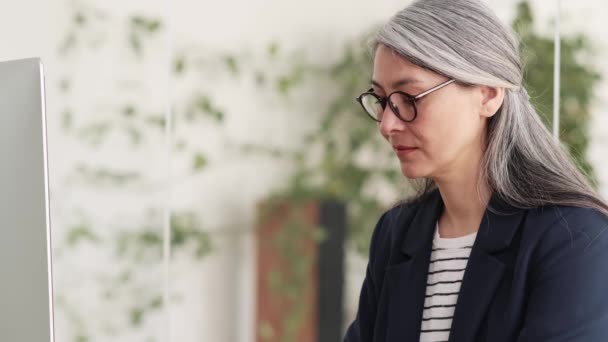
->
[420, 224, 477, 342]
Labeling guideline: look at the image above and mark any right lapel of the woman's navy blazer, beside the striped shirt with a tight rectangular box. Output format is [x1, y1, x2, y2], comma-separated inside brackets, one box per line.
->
[449, 193, 525, 342]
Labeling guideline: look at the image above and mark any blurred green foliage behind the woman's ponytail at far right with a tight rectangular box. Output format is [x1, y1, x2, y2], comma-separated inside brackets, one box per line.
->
[513, 1, 600, 186]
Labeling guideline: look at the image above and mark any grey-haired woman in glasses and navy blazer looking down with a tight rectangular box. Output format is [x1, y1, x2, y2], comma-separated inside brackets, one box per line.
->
[344, 0, 608, 342]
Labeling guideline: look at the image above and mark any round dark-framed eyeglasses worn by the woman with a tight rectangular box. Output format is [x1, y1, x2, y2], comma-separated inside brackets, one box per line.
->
[356, 79, 456, 122]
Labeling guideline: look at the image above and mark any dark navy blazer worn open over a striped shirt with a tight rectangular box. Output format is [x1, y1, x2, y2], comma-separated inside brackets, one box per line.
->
[344, 189, 608, 342]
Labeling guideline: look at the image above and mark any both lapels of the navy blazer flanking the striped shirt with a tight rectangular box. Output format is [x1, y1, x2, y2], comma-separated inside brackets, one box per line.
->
[384, 190, 525, 342]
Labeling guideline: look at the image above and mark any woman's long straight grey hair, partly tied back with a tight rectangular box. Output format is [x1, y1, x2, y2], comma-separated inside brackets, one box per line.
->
[371, 0, 608, 215]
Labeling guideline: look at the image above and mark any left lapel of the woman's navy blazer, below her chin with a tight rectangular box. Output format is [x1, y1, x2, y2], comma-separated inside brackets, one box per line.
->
[385, 190, 443, 341]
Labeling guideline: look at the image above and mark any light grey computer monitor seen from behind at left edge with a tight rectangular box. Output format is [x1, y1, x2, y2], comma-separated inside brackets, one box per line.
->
[0, 58, 54, 342]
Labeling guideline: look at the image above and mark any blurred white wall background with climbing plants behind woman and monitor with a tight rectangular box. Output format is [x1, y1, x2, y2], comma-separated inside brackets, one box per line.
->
[0, 0, 608, 342]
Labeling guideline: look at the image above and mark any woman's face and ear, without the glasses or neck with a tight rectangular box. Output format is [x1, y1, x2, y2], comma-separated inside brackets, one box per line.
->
[372, 45, 488, 180]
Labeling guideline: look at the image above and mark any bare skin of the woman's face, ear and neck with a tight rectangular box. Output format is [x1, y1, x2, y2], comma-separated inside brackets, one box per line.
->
[372, 45, 504, 238]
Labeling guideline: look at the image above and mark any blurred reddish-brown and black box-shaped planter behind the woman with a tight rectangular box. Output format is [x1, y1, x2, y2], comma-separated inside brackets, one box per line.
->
[256, 201, 345, 342]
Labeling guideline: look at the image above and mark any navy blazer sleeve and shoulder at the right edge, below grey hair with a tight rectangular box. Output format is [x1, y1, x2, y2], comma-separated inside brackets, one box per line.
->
[516, 206, 608, 341]
